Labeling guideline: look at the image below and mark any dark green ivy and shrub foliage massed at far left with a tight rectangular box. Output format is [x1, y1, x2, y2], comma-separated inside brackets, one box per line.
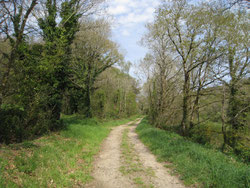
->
[0, 0, 84, 143]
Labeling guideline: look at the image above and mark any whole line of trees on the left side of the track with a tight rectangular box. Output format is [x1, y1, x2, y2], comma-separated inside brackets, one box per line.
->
[0, 0, 137, 144]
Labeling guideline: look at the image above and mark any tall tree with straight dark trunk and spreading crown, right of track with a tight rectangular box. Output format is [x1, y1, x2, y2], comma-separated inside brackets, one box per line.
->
[156, 0, 225, 135]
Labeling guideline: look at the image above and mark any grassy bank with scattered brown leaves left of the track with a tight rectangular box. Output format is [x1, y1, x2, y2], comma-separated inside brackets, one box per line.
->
[0, 116, 136, 188]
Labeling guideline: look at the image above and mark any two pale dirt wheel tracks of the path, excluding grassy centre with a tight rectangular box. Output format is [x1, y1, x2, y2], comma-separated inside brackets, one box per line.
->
[87, 119, 184, 188]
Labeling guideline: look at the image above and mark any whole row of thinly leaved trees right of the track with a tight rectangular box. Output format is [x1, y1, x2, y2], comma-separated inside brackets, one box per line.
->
[140, 0, 250, 161]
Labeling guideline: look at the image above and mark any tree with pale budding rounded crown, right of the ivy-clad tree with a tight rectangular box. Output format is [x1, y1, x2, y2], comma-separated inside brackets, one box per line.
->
[71, 20, 122, 117]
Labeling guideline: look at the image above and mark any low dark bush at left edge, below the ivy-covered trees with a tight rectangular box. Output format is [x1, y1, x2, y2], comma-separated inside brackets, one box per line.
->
[0, 104, 64, 144]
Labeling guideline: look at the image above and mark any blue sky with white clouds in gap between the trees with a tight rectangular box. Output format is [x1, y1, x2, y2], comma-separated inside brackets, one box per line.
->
[107, 0, 160, 70]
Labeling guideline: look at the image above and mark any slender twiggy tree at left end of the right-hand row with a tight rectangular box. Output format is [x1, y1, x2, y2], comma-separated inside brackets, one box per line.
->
[141, 19, 180, 127]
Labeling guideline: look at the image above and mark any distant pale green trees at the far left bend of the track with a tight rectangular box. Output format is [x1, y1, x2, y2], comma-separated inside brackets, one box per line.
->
[91, 68, 139, 118]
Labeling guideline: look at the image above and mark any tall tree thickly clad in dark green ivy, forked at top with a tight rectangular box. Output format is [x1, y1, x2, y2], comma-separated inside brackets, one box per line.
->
[39, 0, 80, 124]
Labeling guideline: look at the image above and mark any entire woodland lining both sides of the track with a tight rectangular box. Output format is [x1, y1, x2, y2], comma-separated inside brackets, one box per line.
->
[0, 0, 250, 162]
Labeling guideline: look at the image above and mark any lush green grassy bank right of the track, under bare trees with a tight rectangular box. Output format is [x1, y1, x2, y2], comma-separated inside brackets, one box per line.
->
[136, 119, 250, 188]
